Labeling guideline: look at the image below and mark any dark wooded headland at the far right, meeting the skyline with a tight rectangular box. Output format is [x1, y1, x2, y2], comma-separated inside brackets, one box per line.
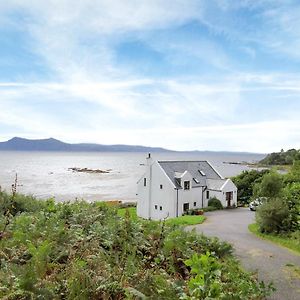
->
[259, 149, 300, 165]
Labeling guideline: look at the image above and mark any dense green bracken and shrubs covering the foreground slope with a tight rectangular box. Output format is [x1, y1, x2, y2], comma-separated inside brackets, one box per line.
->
[0, 190, 272, 300]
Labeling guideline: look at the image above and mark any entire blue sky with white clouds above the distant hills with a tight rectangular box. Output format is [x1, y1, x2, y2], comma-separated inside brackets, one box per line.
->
[0, 0, 300, 153]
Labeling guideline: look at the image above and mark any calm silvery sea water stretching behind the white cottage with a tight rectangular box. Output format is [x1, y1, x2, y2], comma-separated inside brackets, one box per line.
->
[0, 151, 264, 201]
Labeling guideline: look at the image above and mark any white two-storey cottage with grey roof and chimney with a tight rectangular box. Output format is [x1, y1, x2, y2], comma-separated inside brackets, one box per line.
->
[137, 154, 237, 220]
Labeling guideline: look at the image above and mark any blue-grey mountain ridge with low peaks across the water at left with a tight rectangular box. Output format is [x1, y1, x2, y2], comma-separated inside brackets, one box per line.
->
[0, 137, 171, 152]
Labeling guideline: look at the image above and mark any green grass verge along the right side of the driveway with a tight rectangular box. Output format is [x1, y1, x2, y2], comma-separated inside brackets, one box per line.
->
[248, 223, 300, 254]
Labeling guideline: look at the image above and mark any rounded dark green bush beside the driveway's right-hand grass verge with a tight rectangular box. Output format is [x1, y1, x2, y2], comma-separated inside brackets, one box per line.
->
[256, 198, 291, 233]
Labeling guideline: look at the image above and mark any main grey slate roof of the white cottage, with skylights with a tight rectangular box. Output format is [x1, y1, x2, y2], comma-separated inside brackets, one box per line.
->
[158, 161, 224, 189]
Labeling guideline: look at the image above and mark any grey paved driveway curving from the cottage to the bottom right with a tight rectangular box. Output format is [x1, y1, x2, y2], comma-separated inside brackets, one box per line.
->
[190, 208, 300, 300]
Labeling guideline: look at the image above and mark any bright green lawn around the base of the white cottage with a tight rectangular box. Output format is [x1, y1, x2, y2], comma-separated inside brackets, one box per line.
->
[118, 207, 206, 226]
